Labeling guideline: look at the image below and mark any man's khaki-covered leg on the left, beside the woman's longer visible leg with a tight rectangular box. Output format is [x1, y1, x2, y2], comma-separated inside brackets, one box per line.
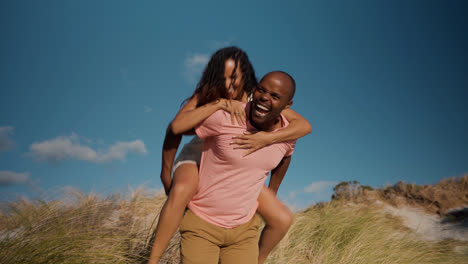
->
[179, 210, 222, 264]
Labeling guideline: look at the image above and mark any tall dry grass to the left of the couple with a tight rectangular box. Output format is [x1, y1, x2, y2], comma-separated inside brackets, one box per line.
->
[0, 189, 164, 264]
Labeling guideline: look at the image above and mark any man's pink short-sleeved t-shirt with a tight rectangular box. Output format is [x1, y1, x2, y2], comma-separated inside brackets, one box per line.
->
[188, 104, 296, 228]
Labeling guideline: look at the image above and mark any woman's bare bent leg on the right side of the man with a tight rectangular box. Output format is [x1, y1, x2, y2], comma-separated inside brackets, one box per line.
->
[257, 186, 293, 264]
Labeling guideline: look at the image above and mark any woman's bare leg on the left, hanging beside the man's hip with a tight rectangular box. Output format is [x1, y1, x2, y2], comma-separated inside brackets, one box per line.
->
[148, 163, 198, 264]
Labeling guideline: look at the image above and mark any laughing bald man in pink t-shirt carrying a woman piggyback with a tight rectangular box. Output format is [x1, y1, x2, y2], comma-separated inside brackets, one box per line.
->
[180, 72, 295, 264]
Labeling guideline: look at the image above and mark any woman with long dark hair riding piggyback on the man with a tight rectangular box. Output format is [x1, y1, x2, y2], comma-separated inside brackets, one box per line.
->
[149, 47, 311, 263]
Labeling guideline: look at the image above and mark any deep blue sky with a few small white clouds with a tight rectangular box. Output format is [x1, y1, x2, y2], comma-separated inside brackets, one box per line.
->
[0, 1, 468, 208]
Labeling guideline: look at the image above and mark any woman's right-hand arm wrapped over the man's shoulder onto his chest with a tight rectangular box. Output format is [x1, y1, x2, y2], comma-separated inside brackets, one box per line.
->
[232, 108, 312, 156]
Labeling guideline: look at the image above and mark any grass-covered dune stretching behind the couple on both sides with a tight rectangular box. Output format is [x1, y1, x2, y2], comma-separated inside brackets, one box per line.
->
[0, 176, 468, 264]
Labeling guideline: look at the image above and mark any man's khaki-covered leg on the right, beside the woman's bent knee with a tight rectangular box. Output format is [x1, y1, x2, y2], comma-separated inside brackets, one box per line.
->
[220, 215, 260, 264]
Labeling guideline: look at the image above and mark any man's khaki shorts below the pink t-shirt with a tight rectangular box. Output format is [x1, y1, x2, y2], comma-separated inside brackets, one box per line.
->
[179, 210, 260, 264]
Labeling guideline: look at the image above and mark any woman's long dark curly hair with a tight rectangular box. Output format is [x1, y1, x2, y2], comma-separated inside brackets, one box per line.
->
[193, 47, 257, 107]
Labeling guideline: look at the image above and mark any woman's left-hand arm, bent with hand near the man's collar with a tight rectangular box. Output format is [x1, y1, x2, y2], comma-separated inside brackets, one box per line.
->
[171, 95, 246, 135]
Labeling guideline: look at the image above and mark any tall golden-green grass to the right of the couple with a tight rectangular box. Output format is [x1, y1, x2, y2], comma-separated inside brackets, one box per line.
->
[267, 201, 468, 264]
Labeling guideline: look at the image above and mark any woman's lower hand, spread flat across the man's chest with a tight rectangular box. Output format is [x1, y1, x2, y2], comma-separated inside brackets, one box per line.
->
[230, 131, 273, 157]
